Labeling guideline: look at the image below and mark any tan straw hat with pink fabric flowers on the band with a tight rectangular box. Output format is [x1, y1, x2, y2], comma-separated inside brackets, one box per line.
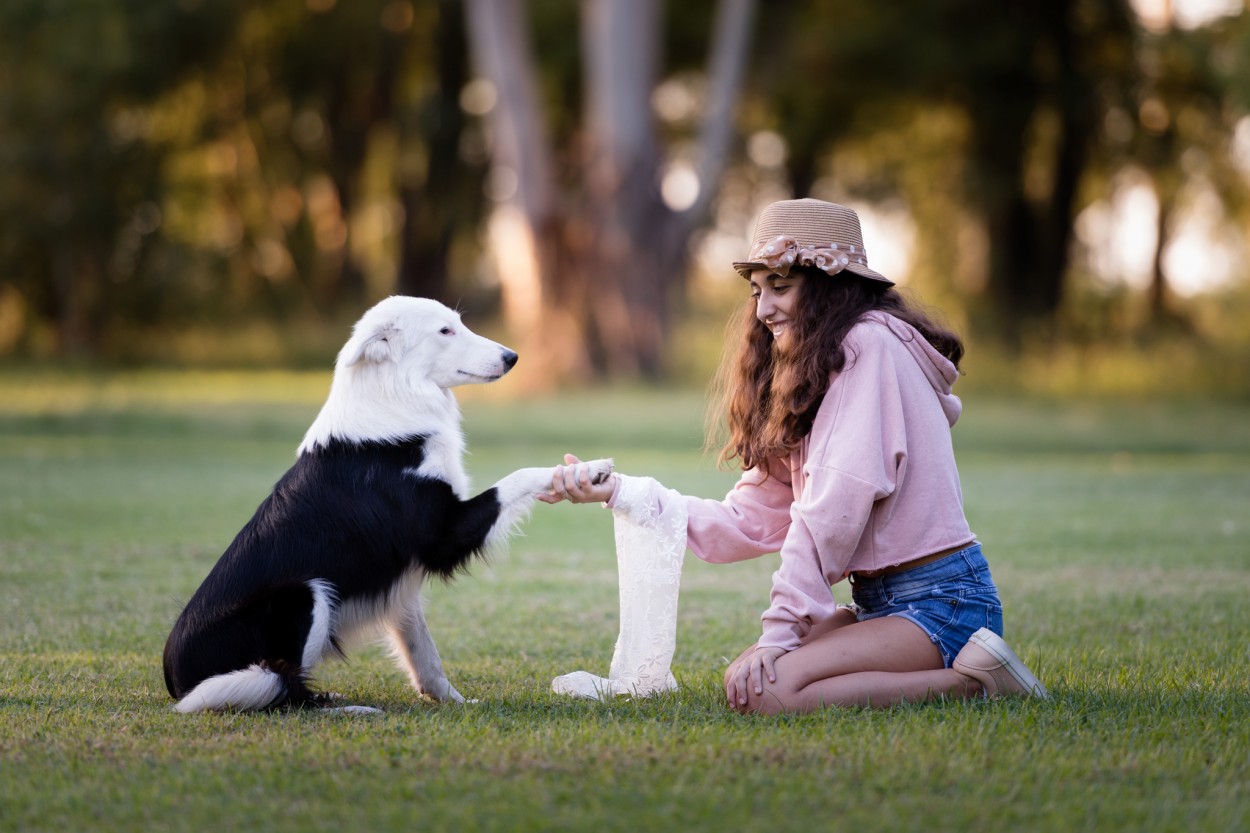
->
[734, 199, 894, 286]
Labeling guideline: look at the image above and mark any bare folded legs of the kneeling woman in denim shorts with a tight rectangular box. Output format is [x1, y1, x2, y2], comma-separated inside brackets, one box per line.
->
[733, 617, 981, 714]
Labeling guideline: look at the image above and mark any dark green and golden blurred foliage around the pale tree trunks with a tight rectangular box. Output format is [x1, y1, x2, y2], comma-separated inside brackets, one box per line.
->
[0, 0, 1250, 377]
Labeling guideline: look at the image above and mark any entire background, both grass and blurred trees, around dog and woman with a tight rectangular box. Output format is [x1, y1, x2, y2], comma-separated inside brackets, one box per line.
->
[0, 6, 1250, 833]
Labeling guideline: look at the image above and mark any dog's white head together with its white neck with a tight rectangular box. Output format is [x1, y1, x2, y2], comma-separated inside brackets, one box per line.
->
[300, 295, 516, 453]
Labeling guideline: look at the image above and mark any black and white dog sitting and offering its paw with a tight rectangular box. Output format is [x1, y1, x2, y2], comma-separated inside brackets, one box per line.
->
[164, 296, 611, 713]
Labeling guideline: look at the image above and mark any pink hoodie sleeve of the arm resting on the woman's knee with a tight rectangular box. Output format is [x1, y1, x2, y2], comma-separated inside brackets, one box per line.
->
[759, 325, 908, 650]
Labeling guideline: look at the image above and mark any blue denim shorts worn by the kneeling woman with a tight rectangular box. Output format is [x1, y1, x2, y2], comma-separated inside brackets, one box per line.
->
[851, 543, 1003, 668]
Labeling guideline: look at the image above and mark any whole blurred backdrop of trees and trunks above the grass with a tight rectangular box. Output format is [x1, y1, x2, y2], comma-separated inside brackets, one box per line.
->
[0, 0, 1250, 396]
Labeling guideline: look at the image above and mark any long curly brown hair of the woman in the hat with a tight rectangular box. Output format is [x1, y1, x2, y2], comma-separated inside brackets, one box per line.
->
[708, 268, 964, 470]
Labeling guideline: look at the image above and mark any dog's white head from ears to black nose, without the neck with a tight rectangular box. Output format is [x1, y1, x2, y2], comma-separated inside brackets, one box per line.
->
[336, 295, 516, 389]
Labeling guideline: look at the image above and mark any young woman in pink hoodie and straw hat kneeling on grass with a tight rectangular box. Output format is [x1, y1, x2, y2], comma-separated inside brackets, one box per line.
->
[551, 199, 1045, 713]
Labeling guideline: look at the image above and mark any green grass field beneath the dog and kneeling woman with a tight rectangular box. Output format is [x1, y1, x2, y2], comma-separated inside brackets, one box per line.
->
[0, 371, 1250, 833]
